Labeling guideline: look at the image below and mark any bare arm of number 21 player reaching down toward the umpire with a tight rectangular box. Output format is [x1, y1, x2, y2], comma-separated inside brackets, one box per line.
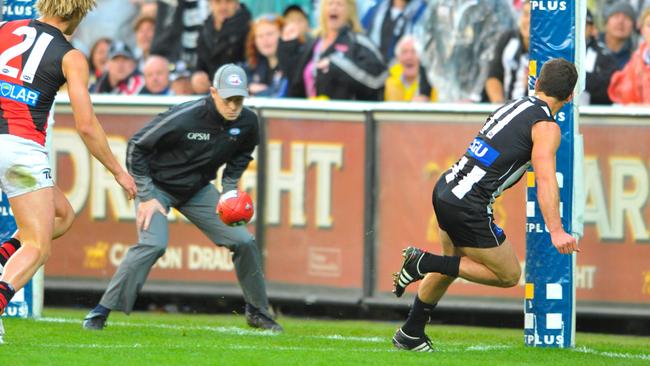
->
[63, 50, 136, 198]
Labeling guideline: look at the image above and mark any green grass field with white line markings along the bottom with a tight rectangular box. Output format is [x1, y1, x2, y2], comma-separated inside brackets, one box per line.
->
[0, 308, 650, 366]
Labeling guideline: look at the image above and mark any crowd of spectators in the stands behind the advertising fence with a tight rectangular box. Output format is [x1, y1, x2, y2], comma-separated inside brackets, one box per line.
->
[73, 0, 650, 104]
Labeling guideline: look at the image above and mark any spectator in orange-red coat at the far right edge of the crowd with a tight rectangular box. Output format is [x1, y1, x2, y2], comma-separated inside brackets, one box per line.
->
[608, 8, 650, 104]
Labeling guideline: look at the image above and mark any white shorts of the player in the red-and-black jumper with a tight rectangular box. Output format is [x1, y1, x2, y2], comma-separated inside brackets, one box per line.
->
[0, 134, 54, 198]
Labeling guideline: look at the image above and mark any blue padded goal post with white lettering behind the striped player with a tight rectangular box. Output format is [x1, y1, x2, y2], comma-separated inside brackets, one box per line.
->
[524, 0, 586, 348]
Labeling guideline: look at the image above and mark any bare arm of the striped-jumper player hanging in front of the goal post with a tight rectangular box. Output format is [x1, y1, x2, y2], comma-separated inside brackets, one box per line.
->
[531, 122, 579, 254]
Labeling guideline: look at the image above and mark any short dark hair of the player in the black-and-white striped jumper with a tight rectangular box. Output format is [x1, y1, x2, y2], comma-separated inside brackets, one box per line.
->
[537, 58, 578, 100]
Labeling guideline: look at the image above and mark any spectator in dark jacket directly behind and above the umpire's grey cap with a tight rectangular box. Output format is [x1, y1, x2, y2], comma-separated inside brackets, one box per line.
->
[192, 0, 251, 94]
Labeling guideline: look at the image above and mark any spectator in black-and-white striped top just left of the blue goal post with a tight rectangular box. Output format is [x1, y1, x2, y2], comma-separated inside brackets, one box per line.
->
[485, 1, 530, 103]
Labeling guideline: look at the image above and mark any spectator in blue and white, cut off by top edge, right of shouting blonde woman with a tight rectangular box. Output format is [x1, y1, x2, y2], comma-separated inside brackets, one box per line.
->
[361, 0, 427, 63]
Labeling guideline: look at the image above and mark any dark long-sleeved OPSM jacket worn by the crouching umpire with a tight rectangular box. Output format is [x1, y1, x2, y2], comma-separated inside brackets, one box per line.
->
[126, 96, 259, 201]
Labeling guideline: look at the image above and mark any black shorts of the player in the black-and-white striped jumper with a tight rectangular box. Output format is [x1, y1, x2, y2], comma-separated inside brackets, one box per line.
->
[432, 177, 506, 248]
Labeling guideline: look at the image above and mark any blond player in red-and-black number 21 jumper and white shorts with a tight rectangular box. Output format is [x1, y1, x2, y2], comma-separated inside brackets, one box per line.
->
[0, 0, 136, 341]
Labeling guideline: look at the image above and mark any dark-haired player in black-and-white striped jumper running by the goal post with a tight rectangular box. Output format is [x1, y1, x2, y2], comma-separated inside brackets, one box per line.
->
[393, 59, 578, 352]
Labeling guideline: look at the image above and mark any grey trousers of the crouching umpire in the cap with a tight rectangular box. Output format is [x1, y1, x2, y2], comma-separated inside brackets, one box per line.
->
[99, 184, 270, 315]
